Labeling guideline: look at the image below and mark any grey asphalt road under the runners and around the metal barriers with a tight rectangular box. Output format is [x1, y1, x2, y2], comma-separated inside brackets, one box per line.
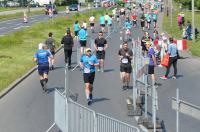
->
[0, 6, 200, 132]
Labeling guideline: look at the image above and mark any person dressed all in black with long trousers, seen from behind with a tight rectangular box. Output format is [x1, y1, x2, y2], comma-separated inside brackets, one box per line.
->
[61, 30, 74, 69]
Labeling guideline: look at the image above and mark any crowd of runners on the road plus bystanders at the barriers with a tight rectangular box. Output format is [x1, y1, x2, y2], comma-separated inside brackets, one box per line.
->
[35, 1, 179, 105]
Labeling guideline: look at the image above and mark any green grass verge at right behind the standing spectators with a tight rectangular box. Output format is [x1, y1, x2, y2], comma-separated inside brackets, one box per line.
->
[163, 4, 200, 57]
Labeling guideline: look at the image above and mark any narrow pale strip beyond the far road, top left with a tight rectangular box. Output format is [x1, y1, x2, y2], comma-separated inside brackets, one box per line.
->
[0, 7, 44, 15]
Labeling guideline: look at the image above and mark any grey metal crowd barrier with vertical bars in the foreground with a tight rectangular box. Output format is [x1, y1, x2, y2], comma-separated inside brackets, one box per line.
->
[50, 90, 140, 132]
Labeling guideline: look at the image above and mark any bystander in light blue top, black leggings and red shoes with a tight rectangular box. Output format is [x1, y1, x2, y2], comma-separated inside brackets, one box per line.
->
[160, 37, 178, 79]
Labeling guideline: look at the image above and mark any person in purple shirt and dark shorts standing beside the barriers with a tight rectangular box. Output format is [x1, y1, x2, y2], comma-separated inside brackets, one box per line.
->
[145, 41, 159, 86]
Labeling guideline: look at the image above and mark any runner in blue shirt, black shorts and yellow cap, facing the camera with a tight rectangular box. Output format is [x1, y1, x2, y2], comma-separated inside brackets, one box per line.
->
[80, 48, 99, 105]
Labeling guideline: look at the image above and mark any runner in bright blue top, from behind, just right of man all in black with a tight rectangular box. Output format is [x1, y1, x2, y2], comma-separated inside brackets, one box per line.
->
[78, 25, 87, 54]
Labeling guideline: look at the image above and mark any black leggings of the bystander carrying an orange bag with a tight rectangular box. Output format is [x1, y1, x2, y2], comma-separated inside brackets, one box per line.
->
[165, 56, 177, 77]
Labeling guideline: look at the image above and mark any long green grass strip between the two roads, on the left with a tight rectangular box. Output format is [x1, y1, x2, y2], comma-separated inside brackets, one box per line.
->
[0, 9, 110, 91]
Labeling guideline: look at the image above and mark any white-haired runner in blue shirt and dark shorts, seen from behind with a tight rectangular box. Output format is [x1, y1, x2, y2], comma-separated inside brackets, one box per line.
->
[34, 43, 52, 92]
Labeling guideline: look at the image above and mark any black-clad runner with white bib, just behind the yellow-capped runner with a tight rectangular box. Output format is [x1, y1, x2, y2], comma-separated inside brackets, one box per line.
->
[94, 31, 108, 72]
